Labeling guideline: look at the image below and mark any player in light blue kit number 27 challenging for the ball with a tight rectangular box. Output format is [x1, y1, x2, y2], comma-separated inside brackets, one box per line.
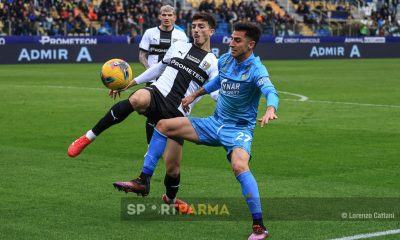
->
[115, 23, 279, 240]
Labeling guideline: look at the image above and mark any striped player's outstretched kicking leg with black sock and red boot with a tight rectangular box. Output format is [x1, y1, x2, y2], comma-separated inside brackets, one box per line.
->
[68, 89, 151, 157]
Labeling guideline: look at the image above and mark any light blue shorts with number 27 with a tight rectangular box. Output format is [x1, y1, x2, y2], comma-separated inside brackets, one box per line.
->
[189, 116, 253, 160]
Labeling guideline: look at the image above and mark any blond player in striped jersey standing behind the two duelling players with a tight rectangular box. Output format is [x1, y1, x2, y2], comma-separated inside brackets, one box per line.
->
[139, 5, 188, 144]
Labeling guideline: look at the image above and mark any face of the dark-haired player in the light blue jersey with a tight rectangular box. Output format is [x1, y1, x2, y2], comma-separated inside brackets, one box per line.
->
[229, 31, 255, 62]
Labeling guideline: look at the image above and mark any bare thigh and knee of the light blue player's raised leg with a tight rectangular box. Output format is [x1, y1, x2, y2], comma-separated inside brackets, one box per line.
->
[156, 117, 199, 143]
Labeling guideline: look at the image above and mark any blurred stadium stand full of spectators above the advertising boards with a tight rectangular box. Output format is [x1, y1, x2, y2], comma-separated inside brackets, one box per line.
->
[0, 0, 400, 37]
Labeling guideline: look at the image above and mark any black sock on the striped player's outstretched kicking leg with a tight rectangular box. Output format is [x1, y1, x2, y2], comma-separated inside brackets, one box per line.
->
[92, 99, 135, 136]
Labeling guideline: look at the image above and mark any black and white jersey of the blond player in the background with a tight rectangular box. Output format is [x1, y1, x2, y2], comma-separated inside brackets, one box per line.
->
[139, 27, 188, 67]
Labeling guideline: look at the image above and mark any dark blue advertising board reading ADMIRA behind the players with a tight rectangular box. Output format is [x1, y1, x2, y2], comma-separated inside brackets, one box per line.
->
[0, 42, 400, 64]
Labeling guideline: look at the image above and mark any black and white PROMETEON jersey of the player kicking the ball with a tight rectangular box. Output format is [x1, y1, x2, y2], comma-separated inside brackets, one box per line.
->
[152, 42, 218, 116]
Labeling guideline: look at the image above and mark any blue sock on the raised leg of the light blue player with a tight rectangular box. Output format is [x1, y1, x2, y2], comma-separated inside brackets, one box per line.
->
[142, 129, 167, 176]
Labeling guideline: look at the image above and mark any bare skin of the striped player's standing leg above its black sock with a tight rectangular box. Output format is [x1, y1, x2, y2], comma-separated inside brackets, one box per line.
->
[164, 139, 182, 175]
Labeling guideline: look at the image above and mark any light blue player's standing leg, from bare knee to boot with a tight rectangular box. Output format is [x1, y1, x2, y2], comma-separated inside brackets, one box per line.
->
[231, 148, 268, 240]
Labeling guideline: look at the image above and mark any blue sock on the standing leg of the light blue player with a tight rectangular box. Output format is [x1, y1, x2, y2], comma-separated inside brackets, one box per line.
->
[236, 170, 262, 221]
